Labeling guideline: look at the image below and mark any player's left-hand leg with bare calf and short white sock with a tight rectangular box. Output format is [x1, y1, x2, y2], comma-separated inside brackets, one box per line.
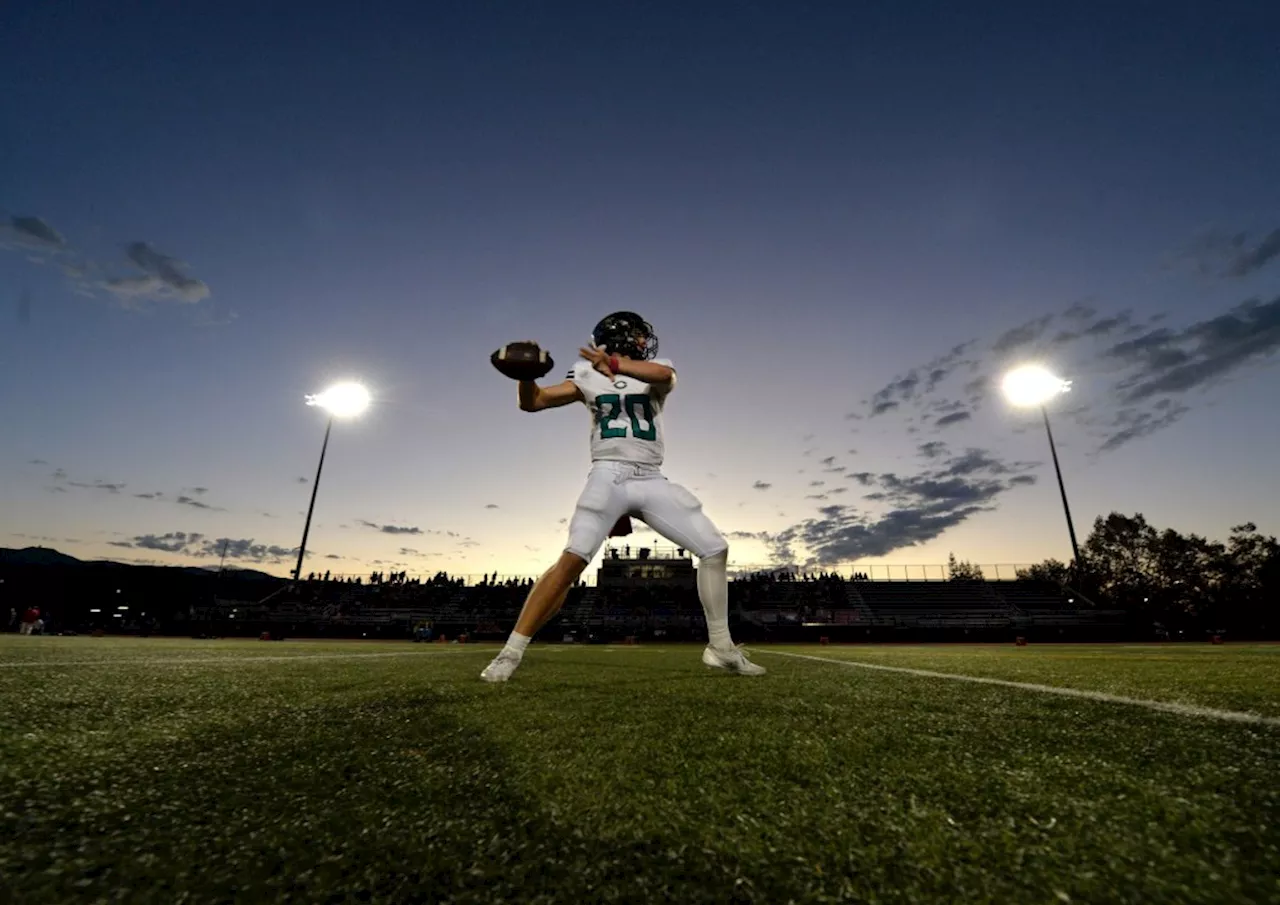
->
[480, 466, 626, 682]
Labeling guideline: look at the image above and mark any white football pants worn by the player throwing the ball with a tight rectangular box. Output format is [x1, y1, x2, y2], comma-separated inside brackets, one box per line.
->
[564, 461, 728, 562]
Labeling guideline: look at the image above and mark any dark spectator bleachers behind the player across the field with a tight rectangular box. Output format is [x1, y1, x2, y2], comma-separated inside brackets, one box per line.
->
[193, 565, 1124, 641]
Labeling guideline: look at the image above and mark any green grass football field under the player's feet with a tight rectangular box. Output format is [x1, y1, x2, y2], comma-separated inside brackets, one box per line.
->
[0, 635, 1280, 902]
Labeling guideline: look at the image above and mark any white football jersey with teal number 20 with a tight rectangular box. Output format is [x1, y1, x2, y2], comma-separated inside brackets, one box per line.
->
[568, 358, 675, 465]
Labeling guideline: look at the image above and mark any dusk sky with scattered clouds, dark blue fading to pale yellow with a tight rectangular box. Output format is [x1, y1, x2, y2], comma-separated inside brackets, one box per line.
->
[0, 0, 1280, 575]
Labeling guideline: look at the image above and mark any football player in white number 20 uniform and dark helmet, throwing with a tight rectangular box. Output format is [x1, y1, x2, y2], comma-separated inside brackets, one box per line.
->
[480, 311, 764, 682]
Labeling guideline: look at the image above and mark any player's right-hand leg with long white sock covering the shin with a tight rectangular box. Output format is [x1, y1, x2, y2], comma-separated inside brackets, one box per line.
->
[634, 477, 764, 676]
